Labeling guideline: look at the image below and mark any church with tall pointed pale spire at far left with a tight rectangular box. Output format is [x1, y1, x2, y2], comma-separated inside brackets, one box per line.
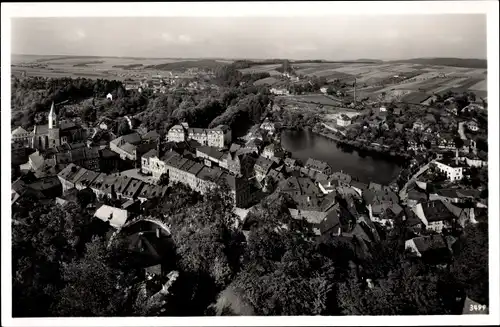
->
[31, 102, 86, 150]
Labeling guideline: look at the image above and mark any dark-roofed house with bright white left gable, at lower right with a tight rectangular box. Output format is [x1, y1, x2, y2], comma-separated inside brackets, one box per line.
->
[413, 200, 455, 233]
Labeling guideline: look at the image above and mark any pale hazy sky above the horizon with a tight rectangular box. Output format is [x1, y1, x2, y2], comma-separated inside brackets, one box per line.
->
[12, 14, 487, 60]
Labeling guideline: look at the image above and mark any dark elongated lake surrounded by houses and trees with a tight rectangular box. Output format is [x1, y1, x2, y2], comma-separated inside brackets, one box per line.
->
[281, 130, 401, 184]
